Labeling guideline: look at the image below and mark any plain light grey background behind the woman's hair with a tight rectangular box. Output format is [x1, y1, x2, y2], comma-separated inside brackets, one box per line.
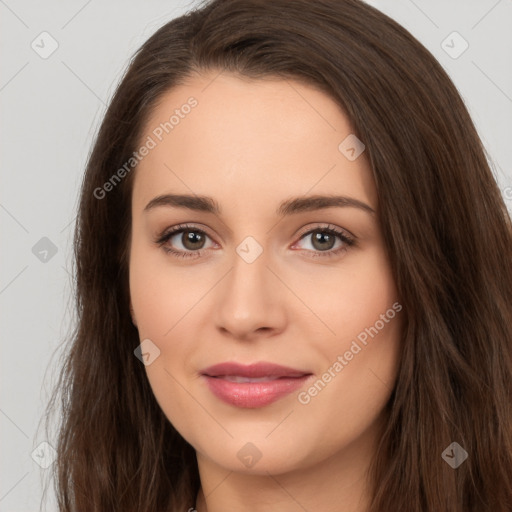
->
[0, 0, 512, 512]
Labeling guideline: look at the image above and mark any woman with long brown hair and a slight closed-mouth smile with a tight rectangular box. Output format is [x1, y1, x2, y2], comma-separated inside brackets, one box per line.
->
[43, 0, 512, 512]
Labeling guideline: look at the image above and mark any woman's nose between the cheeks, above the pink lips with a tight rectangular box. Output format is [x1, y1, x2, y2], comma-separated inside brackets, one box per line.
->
[215, 247, 290, 340]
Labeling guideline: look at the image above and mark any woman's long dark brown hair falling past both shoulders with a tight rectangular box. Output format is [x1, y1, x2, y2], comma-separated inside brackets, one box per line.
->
[42, 0, 512, 512]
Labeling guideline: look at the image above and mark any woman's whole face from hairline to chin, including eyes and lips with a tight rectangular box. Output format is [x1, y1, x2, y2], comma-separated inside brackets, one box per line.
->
[129, 73, 403, 474]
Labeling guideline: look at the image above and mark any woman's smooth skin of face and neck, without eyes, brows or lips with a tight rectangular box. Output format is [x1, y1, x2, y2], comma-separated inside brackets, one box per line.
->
[130, 71, 403, 512]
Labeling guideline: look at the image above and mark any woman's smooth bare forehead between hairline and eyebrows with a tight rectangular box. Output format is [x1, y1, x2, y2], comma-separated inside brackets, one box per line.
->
[133, 71, 377, 215]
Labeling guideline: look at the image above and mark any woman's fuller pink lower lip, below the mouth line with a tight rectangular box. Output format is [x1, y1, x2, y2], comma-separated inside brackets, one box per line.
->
[202, 375, 311, 408]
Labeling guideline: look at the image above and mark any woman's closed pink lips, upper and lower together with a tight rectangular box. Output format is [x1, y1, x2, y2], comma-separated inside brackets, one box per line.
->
[200, 362, 312, 408]
